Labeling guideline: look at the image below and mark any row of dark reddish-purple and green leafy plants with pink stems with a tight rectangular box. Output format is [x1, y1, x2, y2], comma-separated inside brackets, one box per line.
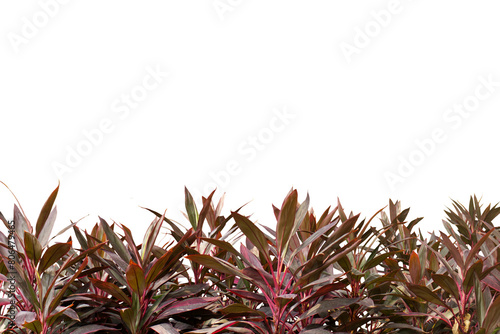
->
[0, 187, 500, 334]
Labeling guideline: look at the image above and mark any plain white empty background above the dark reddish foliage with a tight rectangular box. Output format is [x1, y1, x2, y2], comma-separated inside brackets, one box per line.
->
[0, 0, 500, 239]
